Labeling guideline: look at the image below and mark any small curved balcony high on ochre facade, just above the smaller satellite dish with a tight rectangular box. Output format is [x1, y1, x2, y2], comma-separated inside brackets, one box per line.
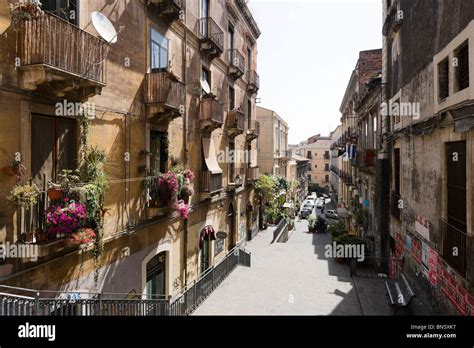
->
[198, 17, 224, 59]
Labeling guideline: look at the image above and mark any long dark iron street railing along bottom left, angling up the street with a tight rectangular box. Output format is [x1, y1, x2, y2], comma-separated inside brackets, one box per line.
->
[0, 247, 251, 316]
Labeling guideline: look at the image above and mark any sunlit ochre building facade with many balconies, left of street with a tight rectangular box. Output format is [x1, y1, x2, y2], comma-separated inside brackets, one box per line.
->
[0, 0, 260, 297]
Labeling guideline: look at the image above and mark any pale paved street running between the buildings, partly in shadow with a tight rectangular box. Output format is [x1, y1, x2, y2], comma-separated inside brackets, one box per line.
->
[194, 220, 391, 315]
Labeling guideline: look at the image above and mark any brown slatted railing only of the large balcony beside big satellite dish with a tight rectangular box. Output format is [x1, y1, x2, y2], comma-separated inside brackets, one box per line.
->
[19, 12, 107, 85]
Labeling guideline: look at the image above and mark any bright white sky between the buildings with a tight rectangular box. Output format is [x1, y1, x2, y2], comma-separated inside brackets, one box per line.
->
[248, 0, 382, 144]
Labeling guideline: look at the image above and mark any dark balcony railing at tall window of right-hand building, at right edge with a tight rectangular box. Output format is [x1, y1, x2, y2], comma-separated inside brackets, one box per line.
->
[439, 219, 474, 281]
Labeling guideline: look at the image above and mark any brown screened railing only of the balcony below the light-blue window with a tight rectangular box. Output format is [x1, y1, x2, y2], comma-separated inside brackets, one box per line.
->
[145, 72, 186, 110]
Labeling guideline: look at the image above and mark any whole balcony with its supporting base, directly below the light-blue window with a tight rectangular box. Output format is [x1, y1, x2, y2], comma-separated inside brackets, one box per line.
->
[144, 72, 186, 121]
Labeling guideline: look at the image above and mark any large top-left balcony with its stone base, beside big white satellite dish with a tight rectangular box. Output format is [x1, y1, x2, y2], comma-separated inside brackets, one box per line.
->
[18, 12, 108, 100]
